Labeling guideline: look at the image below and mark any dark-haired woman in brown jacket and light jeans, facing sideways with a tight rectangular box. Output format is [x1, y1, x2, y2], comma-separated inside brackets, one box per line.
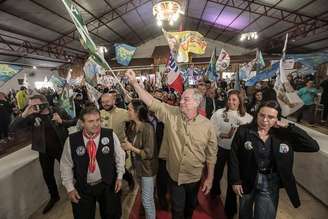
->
[122, 99, 157, 219]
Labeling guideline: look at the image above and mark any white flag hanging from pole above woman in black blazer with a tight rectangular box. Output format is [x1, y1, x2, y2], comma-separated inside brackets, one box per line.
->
[274, 34, 304, 116]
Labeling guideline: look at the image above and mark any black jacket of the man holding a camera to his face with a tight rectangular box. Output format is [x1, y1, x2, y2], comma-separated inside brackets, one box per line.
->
[10, 108, 76, 153]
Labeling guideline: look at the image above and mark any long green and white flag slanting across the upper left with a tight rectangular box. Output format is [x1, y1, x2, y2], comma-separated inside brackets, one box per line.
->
[62, 0, 110, 69]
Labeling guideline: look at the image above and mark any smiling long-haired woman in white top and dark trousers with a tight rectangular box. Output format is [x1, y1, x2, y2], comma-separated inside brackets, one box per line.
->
[211, 90, 252, 218]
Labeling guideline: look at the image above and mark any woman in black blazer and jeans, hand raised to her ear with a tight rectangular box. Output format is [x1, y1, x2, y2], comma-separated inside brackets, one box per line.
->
[229, 101, 319, 219]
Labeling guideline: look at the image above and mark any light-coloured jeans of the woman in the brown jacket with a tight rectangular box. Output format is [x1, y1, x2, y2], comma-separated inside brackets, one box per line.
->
[141, 176, 156, 219]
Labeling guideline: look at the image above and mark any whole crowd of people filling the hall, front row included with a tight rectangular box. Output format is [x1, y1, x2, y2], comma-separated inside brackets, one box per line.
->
[0, 70, 328, 219]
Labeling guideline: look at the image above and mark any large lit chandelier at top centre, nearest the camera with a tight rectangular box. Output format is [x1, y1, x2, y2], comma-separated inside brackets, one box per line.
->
[153, 0, 184, 26]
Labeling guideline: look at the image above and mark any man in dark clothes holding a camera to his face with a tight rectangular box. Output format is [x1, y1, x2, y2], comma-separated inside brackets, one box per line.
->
[11, 94, 76, 214]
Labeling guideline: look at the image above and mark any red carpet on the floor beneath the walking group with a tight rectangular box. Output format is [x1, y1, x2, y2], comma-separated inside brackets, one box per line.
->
[129, 188, 226, 219]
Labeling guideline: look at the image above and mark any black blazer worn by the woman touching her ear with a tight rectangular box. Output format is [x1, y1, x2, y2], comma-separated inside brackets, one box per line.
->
[229, 123, 319, 208]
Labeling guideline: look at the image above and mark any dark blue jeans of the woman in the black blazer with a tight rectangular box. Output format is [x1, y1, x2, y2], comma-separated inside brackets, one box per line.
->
[239, 173, 279, 219]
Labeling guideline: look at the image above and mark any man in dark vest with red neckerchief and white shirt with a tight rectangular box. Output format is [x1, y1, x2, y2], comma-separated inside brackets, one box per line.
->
[60, 107, 125, 219]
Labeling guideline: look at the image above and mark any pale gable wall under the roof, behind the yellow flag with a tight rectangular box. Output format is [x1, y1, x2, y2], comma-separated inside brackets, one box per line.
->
[133, 35, 252, 58]
